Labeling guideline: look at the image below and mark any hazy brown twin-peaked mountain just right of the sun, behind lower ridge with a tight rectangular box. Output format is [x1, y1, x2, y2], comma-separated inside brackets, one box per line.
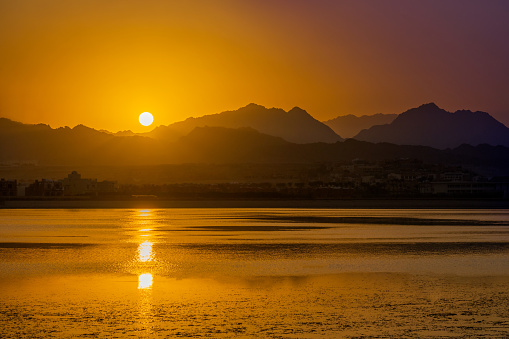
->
[149, 104, 343, 144]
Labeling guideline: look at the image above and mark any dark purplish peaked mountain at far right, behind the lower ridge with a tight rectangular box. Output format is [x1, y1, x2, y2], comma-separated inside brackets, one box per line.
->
[354, 103, 509, 149]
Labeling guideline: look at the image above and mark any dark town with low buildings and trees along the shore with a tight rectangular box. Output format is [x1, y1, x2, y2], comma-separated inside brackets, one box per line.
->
[0, 159, 509, 200]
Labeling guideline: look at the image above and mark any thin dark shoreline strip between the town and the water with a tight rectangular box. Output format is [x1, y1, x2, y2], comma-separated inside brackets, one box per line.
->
[0, 199, 509, 209]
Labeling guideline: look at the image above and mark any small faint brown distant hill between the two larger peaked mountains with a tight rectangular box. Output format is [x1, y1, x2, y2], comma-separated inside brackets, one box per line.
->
[323, 113, 398, 138]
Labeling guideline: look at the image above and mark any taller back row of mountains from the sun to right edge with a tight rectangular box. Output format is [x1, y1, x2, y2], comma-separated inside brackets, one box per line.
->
[144, 103, 509, 149]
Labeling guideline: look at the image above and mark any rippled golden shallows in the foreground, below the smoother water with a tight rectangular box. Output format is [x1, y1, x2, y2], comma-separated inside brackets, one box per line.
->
[0, 273, 509, 338]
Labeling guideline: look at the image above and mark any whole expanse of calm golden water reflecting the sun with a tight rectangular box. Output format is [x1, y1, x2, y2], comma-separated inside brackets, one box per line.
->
[0, 209, 509, 338]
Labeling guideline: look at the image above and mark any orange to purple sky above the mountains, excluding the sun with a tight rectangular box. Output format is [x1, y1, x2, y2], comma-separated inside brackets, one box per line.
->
[0, 0, 509, 131]
